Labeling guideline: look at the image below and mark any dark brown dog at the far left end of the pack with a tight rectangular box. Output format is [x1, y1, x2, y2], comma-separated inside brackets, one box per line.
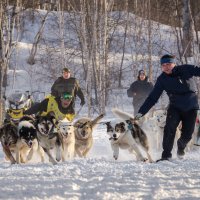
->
[0, 123, 18, 164]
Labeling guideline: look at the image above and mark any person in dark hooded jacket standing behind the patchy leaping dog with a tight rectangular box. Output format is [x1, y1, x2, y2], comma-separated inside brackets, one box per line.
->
[127, 70, 153, 115]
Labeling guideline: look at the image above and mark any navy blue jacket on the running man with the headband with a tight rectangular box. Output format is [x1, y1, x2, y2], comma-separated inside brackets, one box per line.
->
[138, 65, 200, 115]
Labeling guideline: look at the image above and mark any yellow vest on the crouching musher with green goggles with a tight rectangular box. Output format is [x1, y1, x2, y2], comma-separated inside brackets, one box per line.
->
[41, 96, 75, 121]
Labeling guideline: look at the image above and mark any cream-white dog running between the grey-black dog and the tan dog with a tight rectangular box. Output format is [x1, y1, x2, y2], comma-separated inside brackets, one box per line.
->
[58, 119, 75, 161]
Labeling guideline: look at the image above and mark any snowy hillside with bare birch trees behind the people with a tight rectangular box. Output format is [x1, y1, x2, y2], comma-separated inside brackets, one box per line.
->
[0, 0, 200, 122]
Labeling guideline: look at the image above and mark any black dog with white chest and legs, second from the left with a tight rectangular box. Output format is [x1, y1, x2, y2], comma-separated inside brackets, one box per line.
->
[16, 116, 44, 163]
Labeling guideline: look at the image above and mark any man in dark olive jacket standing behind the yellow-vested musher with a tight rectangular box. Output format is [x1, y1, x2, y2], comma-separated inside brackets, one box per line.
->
[51, 68, 85, 108]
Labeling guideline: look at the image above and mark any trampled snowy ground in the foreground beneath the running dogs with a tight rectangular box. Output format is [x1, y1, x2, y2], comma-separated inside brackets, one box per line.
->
[0, 109, 200, 200]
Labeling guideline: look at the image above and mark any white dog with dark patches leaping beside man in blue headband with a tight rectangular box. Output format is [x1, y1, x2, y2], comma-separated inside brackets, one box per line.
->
[106, 109, 152, 162]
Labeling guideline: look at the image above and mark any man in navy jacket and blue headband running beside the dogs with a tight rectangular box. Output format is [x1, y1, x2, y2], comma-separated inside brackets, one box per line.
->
[135, 55, 200, 161]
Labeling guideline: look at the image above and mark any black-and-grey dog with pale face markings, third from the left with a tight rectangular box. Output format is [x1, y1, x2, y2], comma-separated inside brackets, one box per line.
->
[35, 115, 61, 164]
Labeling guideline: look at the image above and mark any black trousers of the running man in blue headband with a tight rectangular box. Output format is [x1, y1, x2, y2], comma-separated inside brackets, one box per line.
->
[162, 106, 197, 158]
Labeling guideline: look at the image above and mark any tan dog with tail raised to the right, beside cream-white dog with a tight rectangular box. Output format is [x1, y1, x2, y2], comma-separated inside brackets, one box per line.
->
[74, 114, 104, 158]
